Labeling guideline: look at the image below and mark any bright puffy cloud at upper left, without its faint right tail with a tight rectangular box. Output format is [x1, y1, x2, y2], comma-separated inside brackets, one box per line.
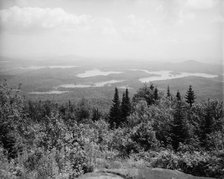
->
[0, 6, 91, 31]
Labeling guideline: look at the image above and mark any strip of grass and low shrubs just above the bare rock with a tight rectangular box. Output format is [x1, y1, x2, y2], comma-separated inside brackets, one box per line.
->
[91, 150, 224, 178]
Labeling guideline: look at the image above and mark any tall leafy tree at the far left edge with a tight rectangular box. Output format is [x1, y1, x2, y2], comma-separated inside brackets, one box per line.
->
[0, 81, 24, 158]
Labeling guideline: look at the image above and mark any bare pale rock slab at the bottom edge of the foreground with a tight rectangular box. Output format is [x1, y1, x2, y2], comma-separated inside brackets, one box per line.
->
[79, 168, 213, 179]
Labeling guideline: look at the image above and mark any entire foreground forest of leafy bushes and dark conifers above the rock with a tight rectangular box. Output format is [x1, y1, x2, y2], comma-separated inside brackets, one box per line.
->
[0, 81, 224, 179]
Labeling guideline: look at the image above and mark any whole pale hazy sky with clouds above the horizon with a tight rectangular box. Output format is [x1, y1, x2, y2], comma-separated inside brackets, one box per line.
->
[0, 0, 224, 62]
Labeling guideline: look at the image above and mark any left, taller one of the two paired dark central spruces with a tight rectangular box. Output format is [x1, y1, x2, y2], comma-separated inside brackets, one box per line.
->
[109, 88, 121, 128]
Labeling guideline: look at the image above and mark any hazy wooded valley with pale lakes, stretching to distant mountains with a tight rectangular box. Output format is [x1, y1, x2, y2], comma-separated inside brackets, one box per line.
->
[0, 57, 224, 106]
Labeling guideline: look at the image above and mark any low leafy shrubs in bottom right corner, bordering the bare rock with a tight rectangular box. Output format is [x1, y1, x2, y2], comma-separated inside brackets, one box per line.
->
[151, 150, 224, 177]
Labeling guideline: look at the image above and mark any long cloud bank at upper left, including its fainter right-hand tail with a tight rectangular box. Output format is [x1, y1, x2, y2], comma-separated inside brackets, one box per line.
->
[0, 6, 117, 36]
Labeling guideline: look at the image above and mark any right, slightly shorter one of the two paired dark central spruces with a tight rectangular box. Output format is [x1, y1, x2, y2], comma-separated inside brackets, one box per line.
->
[121, 89, 131, 123]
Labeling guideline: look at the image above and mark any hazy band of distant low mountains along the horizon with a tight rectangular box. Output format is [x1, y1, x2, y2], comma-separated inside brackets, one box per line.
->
[0, 55, 223, 75]
